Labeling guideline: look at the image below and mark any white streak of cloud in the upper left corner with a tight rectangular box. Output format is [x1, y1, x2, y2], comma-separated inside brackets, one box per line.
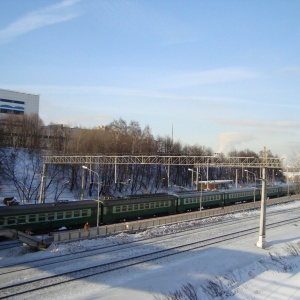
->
[0, 0, 79, 42]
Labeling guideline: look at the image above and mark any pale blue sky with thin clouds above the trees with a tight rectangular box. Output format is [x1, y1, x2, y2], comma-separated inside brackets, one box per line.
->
[0, 0, 300, 162]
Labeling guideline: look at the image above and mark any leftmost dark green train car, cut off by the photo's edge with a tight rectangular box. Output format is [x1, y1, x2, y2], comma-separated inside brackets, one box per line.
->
[0, 200, 97, 233]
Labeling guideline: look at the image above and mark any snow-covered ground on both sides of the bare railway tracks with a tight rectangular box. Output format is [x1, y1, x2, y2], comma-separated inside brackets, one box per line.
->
[0, 201, 300, 300]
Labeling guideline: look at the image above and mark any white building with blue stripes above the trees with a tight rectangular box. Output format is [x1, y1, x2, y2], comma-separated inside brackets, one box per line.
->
[0, 89, 40, 116]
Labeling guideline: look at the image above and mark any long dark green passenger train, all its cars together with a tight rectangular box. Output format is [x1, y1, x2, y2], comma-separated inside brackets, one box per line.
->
[0, 186, 293, 233]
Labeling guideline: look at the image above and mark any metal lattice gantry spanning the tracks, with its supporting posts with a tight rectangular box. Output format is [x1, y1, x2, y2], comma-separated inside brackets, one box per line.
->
[40, 148, 282, 249]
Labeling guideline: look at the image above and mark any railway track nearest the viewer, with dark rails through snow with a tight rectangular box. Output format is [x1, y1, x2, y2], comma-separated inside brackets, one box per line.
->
[0, 216, 300, 299]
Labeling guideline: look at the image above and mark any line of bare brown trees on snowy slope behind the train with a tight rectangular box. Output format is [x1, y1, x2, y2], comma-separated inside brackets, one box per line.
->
[0, 115, 282, 201]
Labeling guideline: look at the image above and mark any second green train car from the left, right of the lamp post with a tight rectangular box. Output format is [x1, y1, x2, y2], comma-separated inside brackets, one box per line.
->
[101, 194, 177, 224]
